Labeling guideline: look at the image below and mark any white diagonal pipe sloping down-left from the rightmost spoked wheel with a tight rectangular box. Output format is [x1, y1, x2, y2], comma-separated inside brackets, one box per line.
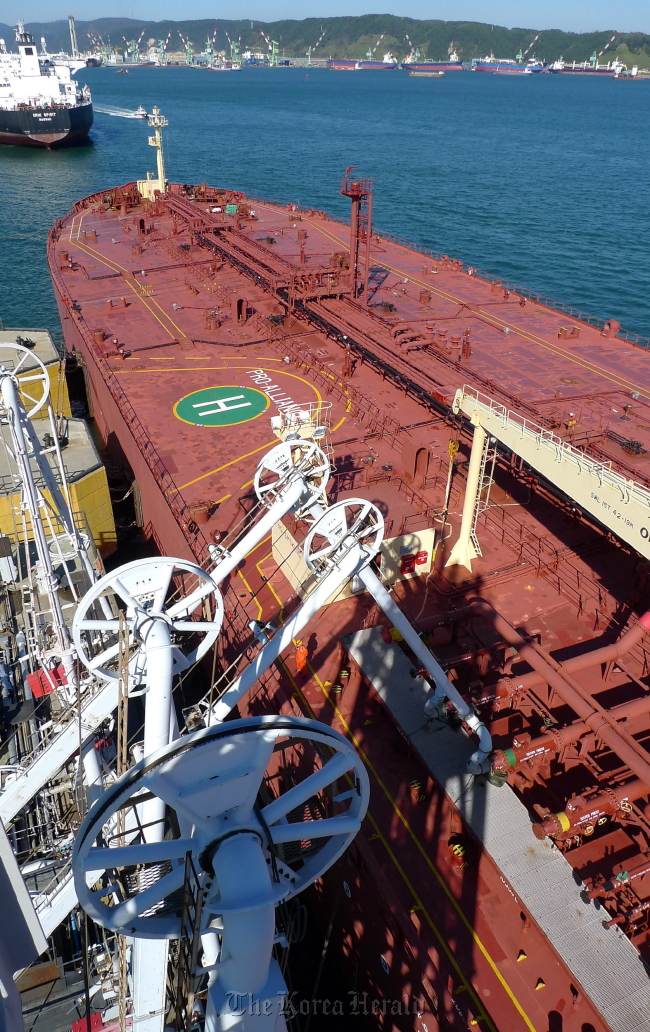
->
[207, 545, 367, 725]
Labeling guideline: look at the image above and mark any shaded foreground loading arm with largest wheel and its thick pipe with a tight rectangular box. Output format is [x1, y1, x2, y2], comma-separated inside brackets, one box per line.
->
[72, 716, 368, 1032]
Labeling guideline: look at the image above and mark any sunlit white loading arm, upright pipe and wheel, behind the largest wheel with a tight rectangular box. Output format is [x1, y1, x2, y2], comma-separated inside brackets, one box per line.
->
[72, 558, 223, 1032]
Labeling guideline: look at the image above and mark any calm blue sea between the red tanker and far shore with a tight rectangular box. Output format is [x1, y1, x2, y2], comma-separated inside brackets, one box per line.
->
[0, 68, 650, 336]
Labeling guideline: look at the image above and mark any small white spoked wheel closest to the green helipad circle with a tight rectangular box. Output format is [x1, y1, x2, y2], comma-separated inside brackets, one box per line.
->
[253, 441, 331, 506]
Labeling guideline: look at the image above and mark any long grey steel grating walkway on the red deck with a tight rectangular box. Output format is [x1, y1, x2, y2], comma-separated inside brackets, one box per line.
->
[343, 627, 650, 1032]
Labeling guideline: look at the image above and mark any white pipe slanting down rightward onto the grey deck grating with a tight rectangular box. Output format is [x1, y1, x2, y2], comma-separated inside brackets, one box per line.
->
[359, 567, 492, 774]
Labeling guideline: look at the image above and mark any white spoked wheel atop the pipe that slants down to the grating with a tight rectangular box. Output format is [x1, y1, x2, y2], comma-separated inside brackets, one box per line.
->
[302, 498, 384, 574]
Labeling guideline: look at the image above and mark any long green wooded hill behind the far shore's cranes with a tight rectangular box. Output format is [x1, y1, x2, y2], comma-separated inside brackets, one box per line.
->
[0, 14, 650, 67]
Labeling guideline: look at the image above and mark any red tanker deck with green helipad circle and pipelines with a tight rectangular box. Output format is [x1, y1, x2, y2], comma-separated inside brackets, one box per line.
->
[48, 173, 650, 1032]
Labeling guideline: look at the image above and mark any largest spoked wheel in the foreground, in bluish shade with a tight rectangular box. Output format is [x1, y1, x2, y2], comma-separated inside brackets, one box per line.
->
[72, 716, 368, 938]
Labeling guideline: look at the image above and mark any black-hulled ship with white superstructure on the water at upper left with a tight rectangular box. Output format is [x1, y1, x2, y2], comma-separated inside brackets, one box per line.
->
[0, 21, 93, 149]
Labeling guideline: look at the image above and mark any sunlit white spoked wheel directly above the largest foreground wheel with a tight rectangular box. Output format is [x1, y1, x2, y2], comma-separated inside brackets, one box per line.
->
[72, 557, 224, 684]
